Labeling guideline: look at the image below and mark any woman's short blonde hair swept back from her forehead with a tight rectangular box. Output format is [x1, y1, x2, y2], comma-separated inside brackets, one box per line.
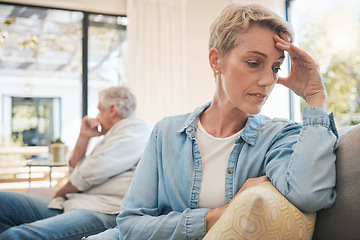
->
[209, 3, 293, 55]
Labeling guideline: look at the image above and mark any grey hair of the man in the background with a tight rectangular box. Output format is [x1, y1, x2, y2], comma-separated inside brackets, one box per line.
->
[99, 87, 136, 118]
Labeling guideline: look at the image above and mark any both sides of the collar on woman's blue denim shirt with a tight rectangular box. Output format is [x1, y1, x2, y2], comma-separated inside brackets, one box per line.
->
[176, 102, 261, 146]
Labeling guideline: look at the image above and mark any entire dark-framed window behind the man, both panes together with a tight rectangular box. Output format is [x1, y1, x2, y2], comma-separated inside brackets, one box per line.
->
[0, 4, 127, 146]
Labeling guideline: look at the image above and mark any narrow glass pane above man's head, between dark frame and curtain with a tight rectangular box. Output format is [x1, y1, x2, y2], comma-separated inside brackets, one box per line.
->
[88, 14, 127, 117]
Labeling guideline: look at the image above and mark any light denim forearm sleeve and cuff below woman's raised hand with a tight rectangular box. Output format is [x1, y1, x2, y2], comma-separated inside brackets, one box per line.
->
[286, 107, 338, 212]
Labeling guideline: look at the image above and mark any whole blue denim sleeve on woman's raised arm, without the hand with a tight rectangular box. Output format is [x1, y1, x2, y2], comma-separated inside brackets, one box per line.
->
[265, 107, 337, 212]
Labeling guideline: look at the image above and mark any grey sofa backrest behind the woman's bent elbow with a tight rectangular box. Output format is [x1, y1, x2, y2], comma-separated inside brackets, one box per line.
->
[313, 124, 360, 240]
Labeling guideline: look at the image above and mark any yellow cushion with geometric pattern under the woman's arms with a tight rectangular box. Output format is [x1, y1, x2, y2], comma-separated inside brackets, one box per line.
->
[204, 182, 316, 240]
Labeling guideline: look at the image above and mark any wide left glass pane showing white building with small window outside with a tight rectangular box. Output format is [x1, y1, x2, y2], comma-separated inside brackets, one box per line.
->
[0, 4, 83, 146]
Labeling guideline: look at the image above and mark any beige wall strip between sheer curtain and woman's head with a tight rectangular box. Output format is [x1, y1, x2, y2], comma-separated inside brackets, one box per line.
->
[186, 0, 226, 111]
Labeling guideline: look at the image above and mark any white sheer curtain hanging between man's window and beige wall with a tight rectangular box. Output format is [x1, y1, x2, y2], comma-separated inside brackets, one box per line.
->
[127, 0, 188, 124]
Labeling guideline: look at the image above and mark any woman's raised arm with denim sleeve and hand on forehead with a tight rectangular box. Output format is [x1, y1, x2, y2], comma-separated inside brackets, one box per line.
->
[266, 33, 337, 212]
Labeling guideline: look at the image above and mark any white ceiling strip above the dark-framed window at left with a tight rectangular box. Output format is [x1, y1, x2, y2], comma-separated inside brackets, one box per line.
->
[0, 0, 126, 15]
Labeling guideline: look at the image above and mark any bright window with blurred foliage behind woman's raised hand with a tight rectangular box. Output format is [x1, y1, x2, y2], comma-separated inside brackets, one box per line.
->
[290, 0, 360, 127]
